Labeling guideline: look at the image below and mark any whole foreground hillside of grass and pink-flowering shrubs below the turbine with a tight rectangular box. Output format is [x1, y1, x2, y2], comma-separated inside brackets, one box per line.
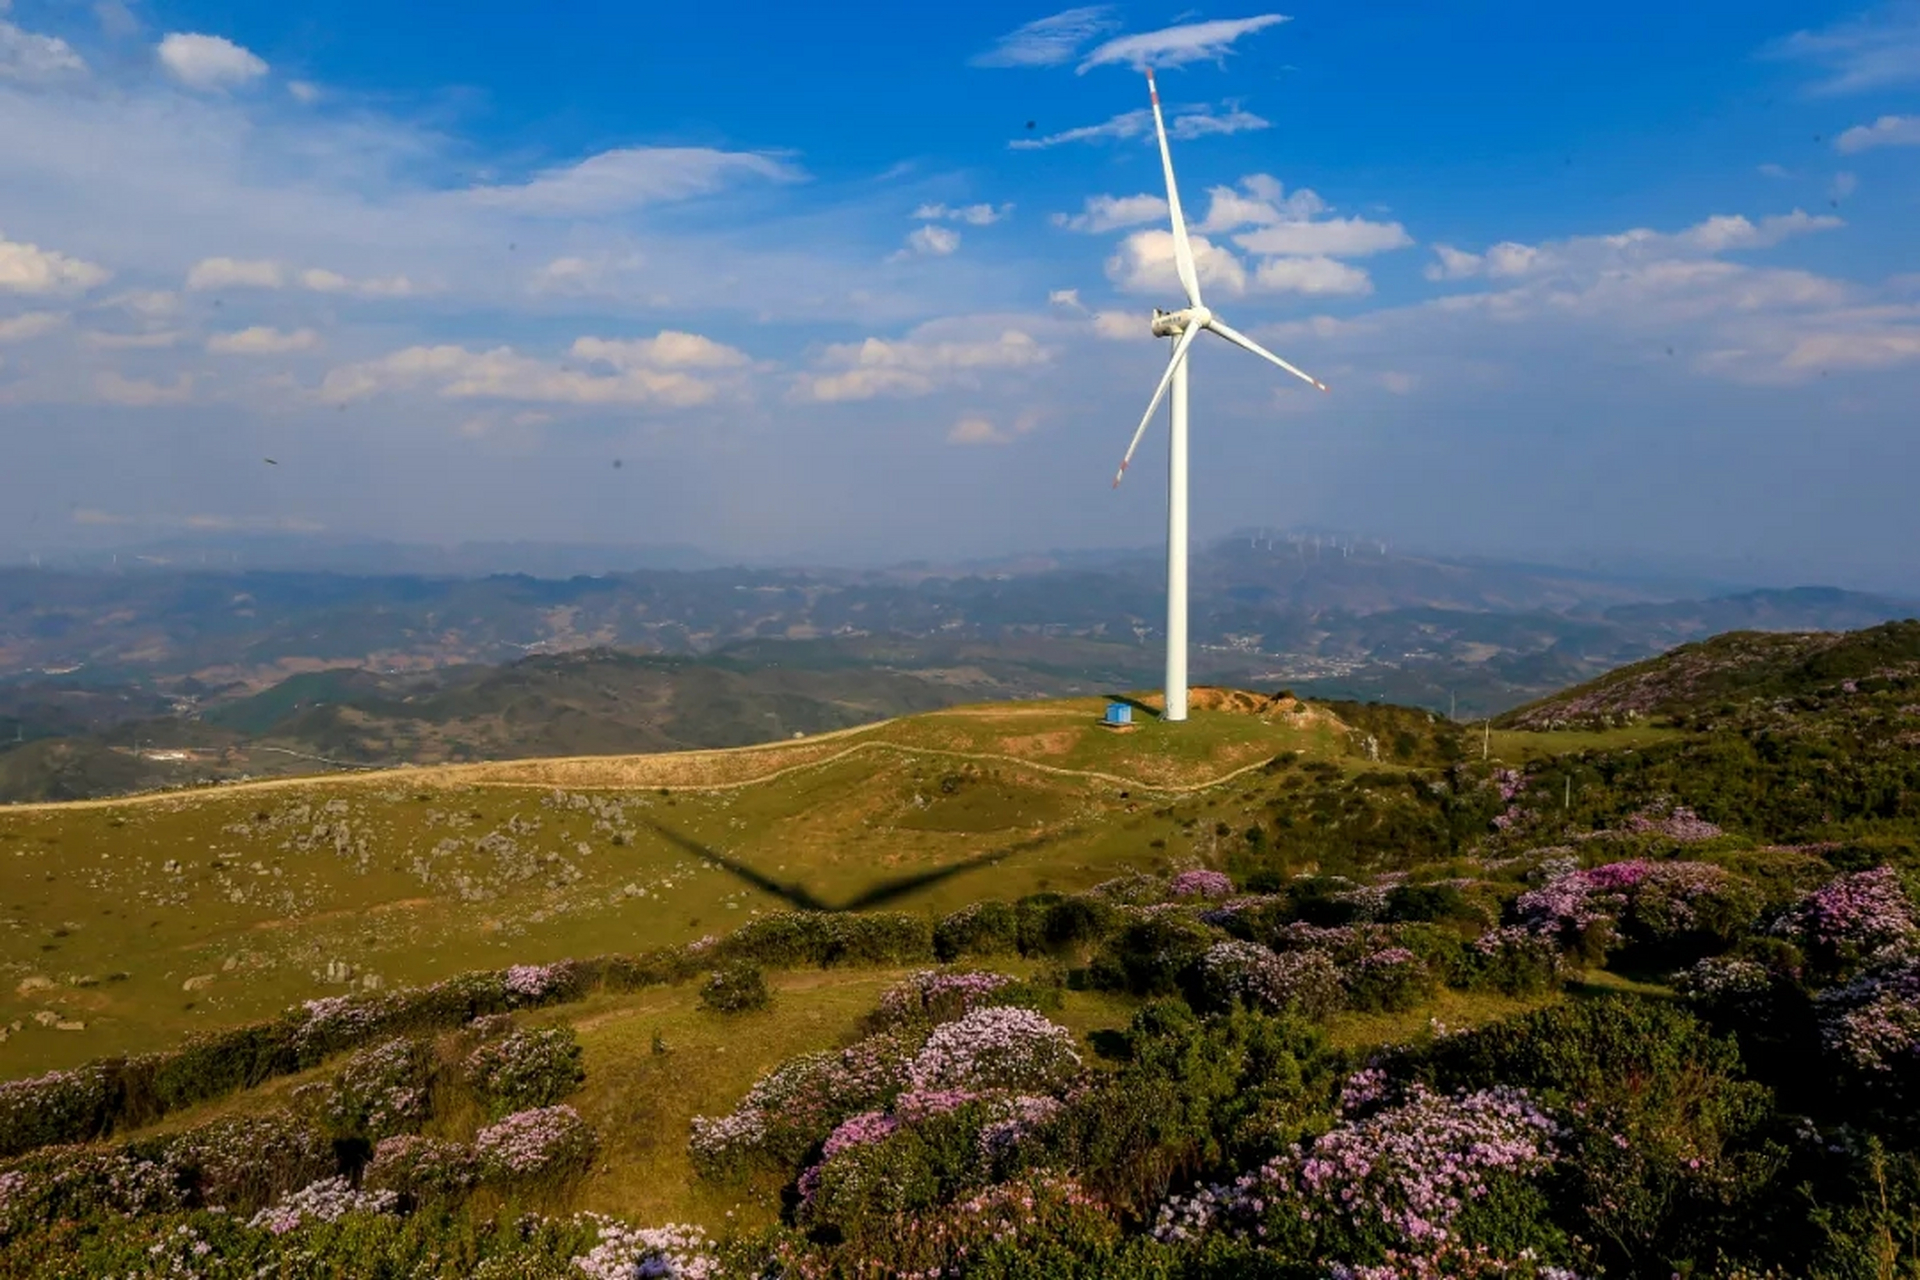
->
[11, 640, 1920, 1280]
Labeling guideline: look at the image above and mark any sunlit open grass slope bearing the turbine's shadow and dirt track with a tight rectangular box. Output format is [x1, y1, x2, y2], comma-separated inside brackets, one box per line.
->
[0, 699, 1350, 1077]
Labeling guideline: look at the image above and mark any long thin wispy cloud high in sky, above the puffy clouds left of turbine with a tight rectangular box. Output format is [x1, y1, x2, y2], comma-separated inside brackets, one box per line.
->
[465, 146, 801, 217]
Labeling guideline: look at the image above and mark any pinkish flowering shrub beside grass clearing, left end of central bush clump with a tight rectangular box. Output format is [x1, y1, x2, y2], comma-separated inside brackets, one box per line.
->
[689, 1034, 912, 1176]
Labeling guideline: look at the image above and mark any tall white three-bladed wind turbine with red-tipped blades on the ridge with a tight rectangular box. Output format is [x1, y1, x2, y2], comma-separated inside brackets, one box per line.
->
[1114, 71, 1327, 720]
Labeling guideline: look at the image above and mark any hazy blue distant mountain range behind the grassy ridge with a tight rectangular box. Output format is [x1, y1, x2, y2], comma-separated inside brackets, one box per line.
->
[0, 537, 1920, 798]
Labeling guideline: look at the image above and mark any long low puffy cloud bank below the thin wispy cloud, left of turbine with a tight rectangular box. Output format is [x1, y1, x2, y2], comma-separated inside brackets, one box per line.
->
[321, 334, 720, 409]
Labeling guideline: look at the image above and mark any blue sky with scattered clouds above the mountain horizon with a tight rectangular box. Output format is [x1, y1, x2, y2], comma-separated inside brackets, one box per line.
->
[0, 0, 1920, 589]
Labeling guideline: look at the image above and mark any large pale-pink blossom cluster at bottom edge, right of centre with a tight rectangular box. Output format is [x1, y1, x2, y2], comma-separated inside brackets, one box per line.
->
[1154, 1084, 1559, 1251]
